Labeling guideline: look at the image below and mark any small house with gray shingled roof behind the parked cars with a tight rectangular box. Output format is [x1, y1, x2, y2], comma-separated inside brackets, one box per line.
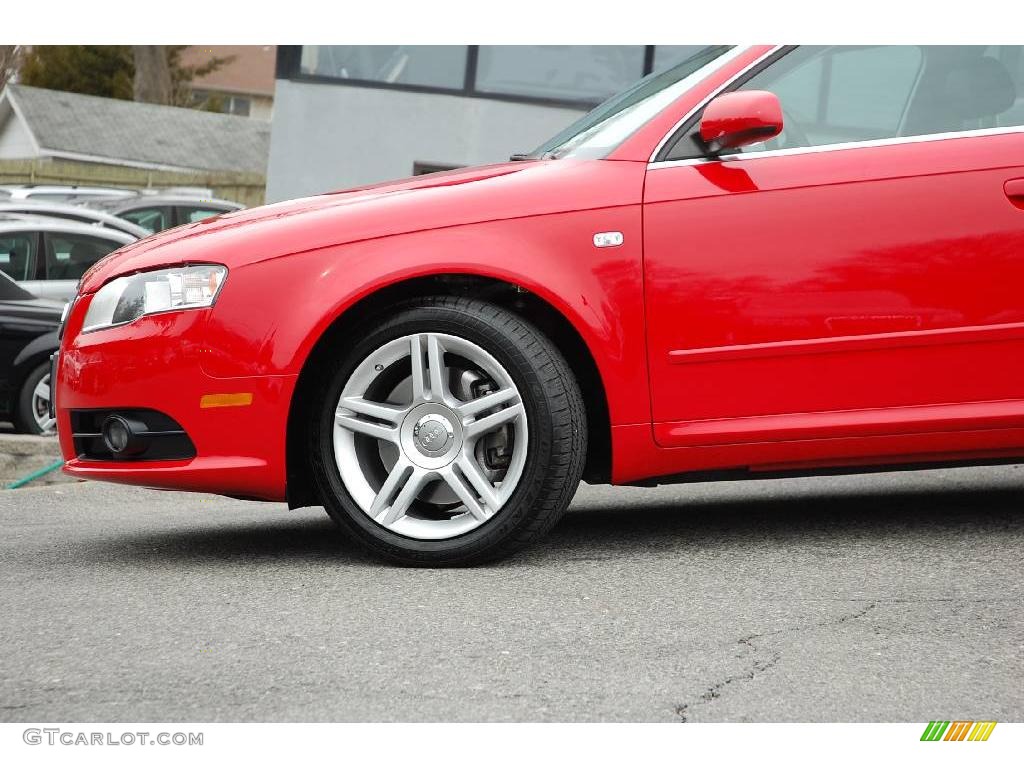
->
[0, 85, 270, 175]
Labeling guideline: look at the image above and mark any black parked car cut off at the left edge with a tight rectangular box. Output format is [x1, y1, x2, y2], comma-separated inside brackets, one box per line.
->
[0, 272, 63, 434]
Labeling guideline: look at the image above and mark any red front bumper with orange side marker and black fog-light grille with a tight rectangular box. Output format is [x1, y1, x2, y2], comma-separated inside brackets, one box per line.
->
[53, 296, 297, 501]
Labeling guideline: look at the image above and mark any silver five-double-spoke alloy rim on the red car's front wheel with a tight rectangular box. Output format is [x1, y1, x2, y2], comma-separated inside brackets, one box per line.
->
[333, 333, 527, 540]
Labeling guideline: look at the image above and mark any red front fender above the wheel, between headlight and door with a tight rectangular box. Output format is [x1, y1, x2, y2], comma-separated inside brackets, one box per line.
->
[203, 205, 650, 425]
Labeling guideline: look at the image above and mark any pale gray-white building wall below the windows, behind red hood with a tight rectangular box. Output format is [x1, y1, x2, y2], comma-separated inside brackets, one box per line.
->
[266, 80, 583, 203]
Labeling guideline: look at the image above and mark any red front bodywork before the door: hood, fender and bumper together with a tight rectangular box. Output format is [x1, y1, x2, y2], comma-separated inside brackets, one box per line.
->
[56, 161, 650, 500]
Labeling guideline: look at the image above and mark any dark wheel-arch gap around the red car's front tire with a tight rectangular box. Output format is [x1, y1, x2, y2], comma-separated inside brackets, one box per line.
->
[286, 273, 611, 508]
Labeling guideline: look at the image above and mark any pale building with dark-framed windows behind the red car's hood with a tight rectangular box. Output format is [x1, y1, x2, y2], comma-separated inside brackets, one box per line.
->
[267, 45, 702, 202]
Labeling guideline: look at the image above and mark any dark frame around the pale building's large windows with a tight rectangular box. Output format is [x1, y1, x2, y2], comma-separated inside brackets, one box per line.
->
[274, 45, 654, 111]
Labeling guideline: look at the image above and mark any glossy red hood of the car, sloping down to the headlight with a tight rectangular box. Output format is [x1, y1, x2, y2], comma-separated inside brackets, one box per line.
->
[80, 160, 644, 293]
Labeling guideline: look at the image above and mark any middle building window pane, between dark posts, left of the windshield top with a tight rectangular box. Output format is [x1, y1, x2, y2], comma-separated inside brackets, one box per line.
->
[476, 45, 644, 101]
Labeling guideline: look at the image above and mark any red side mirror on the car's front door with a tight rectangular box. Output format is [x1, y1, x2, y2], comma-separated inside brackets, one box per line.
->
[700, 91, 782, 155]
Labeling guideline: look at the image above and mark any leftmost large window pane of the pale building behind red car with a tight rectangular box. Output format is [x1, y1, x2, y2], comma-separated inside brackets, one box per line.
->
[299, 45, 467, 89]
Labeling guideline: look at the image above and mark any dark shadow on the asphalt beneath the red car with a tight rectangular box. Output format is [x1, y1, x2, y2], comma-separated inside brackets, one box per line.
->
[83, 482, 1024, 568]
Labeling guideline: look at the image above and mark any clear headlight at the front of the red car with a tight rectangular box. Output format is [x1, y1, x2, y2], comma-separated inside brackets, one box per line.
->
[82, 264, 227, 332]
